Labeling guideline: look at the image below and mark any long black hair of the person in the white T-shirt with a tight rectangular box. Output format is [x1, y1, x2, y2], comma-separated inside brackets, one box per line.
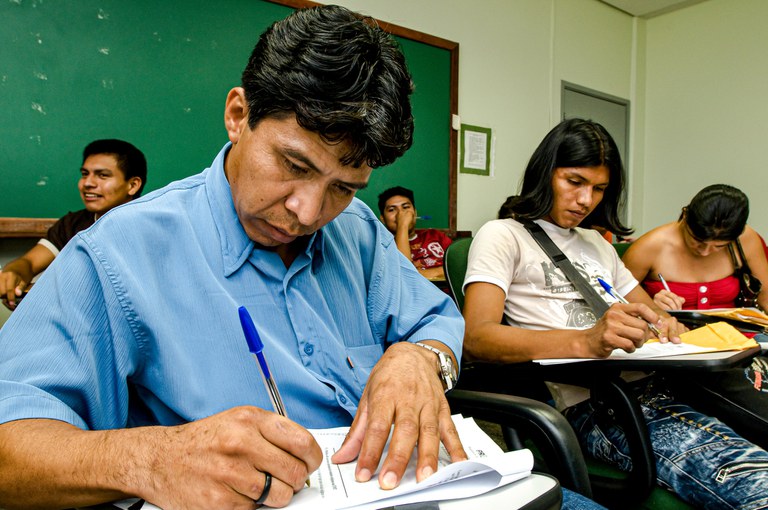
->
[500, 119, 634, 236]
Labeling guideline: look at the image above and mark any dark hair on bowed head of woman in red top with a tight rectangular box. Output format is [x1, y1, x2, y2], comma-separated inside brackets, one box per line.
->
[680, 184, 749, 241]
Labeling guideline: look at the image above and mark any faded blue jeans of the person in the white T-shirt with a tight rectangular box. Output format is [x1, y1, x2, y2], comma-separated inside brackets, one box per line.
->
[564, 376, 768, 510]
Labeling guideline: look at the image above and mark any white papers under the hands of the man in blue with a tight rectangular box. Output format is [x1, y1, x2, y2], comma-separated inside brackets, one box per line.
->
[115, 415, 533, 510]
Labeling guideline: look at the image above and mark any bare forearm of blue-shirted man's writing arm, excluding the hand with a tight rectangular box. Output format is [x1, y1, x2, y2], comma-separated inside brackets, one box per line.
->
[0, 419, 153, 510]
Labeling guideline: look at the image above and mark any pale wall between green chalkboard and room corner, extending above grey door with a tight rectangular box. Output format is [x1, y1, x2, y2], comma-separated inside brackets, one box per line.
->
[316, 0, 635, 232]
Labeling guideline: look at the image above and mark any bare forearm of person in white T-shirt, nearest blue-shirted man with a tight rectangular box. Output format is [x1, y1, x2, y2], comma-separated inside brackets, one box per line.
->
[464, 322, 593, 363]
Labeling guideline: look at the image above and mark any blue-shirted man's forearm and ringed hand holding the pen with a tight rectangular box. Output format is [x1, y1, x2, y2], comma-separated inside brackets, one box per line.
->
[0, 407, 322, 510]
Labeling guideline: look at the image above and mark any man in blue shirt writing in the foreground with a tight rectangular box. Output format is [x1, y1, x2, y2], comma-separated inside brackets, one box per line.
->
[0, 6, 465, 510]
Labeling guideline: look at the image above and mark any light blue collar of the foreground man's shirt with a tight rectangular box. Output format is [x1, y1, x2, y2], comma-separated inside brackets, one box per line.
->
[205, 142, 325, 277]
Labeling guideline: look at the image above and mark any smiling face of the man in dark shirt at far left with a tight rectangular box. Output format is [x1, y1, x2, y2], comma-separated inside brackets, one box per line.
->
[77, 154, 141, 216]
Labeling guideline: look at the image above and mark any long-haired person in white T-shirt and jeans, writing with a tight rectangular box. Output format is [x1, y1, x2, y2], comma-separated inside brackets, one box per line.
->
[462, 119, 768, 508]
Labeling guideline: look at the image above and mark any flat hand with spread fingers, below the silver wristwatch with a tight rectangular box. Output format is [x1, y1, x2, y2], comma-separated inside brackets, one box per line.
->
[331, 342, 467, 489]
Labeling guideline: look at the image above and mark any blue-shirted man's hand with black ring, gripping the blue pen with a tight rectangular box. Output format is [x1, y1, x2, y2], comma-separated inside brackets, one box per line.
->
[142, 407, 322, 510]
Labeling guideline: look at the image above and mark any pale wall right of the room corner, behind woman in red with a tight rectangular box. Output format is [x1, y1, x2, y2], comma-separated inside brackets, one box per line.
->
[642, 0, 768, 234]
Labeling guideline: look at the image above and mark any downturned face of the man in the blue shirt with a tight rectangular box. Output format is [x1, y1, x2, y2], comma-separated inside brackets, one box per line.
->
[225, 101, 371, 247]
